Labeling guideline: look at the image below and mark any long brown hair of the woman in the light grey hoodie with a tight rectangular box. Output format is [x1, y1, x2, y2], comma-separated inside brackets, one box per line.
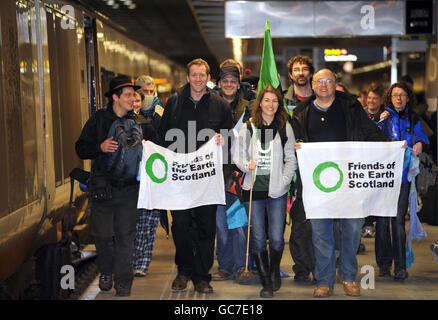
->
[251, 86, 288, 130]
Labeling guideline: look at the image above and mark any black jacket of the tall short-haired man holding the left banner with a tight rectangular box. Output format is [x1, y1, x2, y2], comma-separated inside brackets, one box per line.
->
[158, 83, 232, 152]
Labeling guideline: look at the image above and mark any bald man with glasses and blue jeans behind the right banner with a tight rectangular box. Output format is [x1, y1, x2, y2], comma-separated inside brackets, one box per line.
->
[292, 68, 389, 297]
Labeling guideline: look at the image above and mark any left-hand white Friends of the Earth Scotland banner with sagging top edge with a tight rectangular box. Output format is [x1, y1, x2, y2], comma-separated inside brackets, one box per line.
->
[137, 137, 225, 210]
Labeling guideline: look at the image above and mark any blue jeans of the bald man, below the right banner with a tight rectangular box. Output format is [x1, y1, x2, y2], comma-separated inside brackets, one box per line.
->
[311, 218, 365, 290]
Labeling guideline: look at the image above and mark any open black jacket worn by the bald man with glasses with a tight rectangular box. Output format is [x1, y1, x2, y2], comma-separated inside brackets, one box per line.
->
[292, 91, 391, 142]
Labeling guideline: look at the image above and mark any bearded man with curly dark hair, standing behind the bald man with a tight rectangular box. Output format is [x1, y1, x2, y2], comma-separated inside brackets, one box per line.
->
[284, 55, 315, 282]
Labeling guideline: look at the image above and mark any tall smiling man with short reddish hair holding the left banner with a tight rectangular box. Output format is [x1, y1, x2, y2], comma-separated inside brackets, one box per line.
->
[158, 59, 232, 293]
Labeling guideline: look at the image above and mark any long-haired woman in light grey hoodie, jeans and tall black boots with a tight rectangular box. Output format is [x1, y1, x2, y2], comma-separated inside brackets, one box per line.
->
[233, 86, 297, 298]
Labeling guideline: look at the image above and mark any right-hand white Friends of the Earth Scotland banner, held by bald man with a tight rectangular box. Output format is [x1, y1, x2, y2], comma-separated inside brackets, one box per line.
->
[297, 141, 405, 219]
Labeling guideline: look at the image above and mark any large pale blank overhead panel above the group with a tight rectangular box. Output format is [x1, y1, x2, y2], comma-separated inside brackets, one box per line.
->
[225, 1, 406, 38]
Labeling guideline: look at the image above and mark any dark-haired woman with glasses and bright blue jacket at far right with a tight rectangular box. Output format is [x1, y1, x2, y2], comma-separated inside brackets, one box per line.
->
[375, 82, 429, 281]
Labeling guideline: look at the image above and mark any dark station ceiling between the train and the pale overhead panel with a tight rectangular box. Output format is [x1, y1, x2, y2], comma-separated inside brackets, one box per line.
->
[71, 0, 231, 70]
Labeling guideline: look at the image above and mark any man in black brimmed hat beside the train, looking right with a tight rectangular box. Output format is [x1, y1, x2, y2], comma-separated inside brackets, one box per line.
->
[76, 76, 140, 296]
